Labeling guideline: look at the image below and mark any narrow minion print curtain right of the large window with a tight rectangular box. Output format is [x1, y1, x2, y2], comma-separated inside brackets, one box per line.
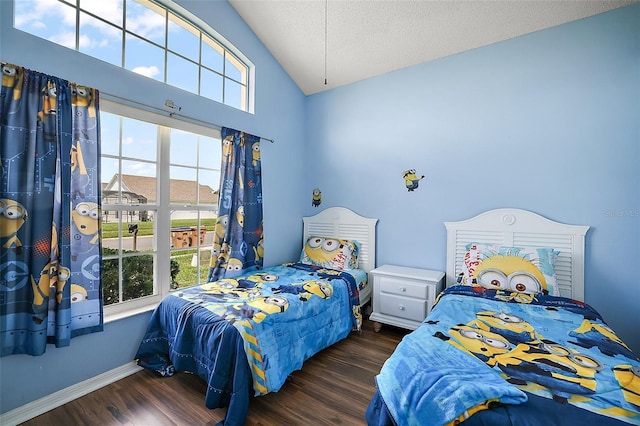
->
[207, 127, 264, 282]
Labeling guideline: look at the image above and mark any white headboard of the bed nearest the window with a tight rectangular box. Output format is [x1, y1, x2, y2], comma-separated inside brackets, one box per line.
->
[302, 207, 378, 272]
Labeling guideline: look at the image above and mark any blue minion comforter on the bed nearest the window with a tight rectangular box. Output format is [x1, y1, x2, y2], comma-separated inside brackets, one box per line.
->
[135, 263, 366, 425]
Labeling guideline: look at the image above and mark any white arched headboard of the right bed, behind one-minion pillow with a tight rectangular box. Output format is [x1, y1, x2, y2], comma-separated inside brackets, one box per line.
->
[444, 209, 589, 301]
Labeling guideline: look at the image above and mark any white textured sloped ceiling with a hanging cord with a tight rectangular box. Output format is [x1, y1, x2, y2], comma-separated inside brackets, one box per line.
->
[229, 0, 640, 95]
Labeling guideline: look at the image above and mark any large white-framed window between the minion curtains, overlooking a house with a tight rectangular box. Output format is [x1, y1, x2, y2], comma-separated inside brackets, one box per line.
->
[100, 100, 221, 315]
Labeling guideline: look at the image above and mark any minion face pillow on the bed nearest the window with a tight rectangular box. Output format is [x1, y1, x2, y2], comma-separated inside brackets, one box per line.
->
[300, 236, 360, 271]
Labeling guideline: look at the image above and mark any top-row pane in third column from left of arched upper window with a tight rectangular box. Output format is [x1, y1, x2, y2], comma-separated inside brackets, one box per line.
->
[124, 0, 166, 46]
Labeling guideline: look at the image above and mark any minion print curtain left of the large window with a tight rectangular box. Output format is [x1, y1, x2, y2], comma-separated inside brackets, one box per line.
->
[0, 64, 103, 356]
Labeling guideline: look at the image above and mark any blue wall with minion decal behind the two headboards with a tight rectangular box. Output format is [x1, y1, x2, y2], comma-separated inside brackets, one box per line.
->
[305, 4, 640, 353]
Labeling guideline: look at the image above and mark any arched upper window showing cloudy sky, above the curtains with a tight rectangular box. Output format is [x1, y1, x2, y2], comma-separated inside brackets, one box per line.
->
[14, 0, 252, 111]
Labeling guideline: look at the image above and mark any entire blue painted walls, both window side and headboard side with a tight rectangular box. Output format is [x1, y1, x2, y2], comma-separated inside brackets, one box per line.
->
[0, 0, 640, 413]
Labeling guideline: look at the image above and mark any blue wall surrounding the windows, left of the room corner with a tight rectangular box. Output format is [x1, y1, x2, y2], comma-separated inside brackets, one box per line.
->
[0, 0, 306, 413]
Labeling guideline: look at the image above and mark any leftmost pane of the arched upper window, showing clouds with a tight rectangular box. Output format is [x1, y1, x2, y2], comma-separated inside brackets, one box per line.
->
[14, 1, 76, 49]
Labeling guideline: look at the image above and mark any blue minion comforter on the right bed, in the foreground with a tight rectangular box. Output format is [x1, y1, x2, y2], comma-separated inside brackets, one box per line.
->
[366, 286, 640, 426]
